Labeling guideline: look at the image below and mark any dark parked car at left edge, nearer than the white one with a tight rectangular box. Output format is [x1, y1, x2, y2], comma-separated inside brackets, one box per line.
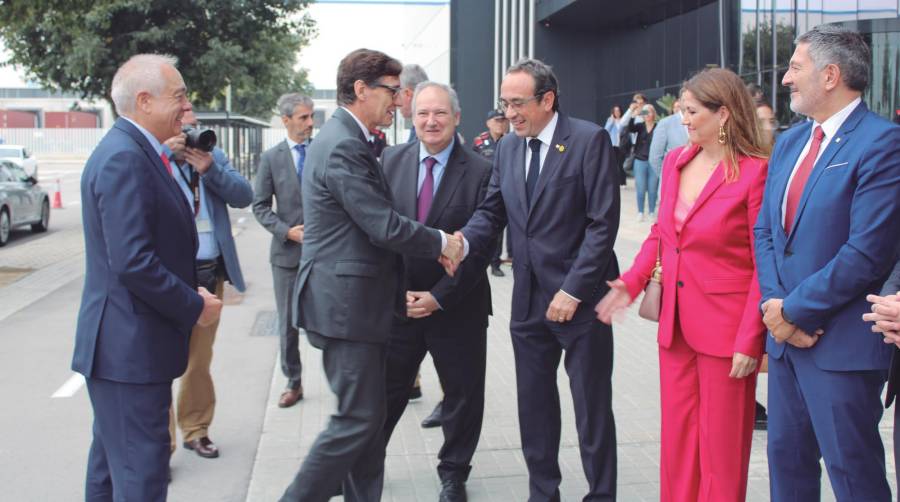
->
[0, 159, 50, 246]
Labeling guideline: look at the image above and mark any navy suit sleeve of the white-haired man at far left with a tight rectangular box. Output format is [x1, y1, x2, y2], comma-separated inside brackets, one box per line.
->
[95, 152, 203, 329]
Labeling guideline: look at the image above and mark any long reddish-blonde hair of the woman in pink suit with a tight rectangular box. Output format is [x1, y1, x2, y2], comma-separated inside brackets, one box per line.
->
[681, 68, 771, 182]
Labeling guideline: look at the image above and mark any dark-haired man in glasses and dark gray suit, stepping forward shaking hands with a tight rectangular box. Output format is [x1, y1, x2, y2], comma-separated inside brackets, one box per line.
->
[282, 49, 464, 502]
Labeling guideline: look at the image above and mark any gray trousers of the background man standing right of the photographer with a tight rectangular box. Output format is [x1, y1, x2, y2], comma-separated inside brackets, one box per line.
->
[272, 265, 303, 389]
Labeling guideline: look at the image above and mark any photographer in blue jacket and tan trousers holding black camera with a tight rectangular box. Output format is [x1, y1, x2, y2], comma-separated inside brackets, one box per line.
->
[163, 110, 253, 458]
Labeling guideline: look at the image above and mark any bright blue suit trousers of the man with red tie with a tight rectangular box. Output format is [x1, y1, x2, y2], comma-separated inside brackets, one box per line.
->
[768, 346, 891, 502]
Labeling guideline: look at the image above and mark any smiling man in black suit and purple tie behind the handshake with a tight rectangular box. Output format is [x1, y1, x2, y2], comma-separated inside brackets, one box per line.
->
[382, 82, 491, 502]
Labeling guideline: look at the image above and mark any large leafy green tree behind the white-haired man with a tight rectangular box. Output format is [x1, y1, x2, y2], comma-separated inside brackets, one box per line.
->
[0, 0, 315, 118]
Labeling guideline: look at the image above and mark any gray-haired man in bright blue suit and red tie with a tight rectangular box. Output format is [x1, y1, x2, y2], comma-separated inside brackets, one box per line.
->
[755, 25, 900, 502]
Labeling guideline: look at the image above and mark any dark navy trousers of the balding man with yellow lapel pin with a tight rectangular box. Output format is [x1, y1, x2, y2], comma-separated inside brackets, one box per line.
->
[510, 294, 617, 502]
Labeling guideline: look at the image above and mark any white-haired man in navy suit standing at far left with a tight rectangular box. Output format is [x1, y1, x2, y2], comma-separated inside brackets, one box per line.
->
[72, 54, 222, 501]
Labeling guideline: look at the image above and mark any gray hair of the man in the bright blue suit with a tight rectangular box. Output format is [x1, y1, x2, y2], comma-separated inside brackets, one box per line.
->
[796, 24, 872, 92]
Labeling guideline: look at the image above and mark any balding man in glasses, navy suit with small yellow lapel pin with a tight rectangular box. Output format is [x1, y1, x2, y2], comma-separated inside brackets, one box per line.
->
[462, 59, 619, 502]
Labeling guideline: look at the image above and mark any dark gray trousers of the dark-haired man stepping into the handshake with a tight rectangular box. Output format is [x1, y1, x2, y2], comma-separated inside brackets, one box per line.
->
[281, 332, 387, 502]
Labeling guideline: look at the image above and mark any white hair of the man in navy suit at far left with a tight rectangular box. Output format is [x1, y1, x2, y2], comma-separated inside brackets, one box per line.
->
[110, 54, 178, 117]
